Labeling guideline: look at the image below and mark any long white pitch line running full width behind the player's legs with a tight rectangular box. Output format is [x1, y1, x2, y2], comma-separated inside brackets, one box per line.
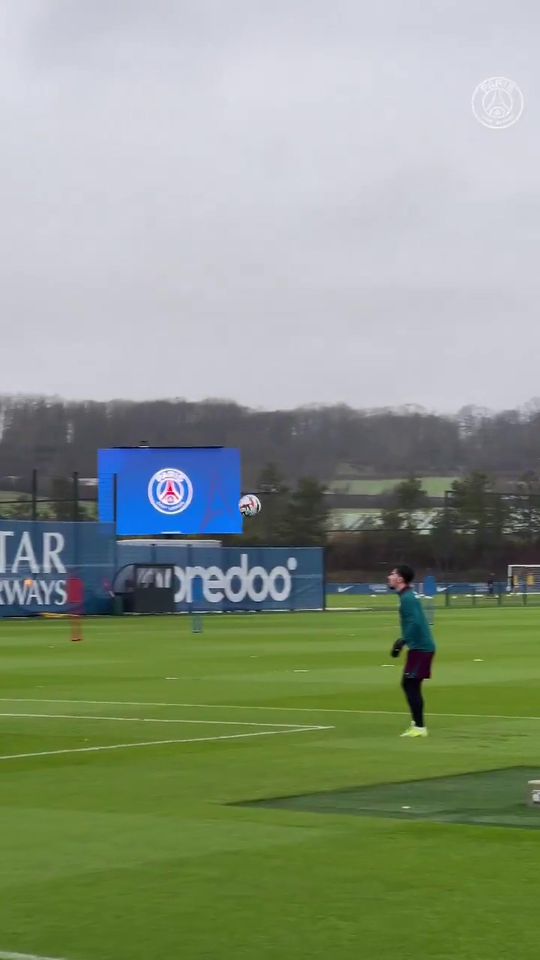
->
[0, 697, 540, 726]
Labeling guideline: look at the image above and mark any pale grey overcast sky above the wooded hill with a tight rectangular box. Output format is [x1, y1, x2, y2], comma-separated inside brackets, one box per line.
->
[0, 0, 540, 411]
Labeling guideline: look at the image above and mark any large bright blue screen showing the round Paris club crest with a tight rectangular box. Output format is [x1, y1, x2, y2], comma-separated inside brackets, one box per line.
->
[98, 447, 242, 536]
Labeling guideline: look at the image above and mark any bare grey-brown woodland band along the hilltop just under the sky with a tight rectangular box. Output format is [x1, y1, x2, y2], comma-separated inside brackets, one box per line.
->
[0, 396, 540, 486]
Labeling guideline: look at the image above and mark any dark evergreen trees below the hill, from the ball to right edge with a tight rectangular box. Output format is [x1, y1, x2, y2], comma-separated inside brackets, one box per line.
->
[228, 465, 540, 581]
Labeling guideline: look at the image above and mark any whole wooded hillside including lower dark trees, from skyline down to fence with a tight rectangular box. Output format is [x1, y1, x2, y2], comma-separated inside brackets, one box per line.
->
[0, 397, 540, 579]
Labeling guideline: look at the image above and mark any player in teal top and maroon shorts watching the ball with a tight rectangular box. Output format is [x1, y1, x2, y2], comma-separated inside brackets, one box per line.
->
[388, 564, 436, 737]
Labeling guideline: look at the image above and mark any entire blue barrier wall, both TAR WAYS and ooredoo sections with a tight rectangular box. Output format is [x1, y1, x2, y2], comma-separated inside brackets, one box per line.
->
[0, 521, 324, 617]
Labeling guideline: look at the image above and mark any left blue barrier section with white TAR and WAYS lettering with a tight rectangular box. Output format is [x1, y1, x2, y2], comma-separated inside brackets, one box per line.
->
[0, 520, 116, 617]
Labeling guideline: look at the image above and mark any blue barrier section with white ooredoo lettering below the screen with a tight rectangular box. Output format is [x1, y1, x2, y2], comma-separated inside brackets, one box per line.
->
[115, 541, 324, 612]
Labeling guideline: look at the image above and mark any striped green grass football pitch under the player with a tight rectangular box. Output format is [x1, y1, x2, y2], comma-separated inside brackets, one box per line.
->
[0, 605, 540, 960]
